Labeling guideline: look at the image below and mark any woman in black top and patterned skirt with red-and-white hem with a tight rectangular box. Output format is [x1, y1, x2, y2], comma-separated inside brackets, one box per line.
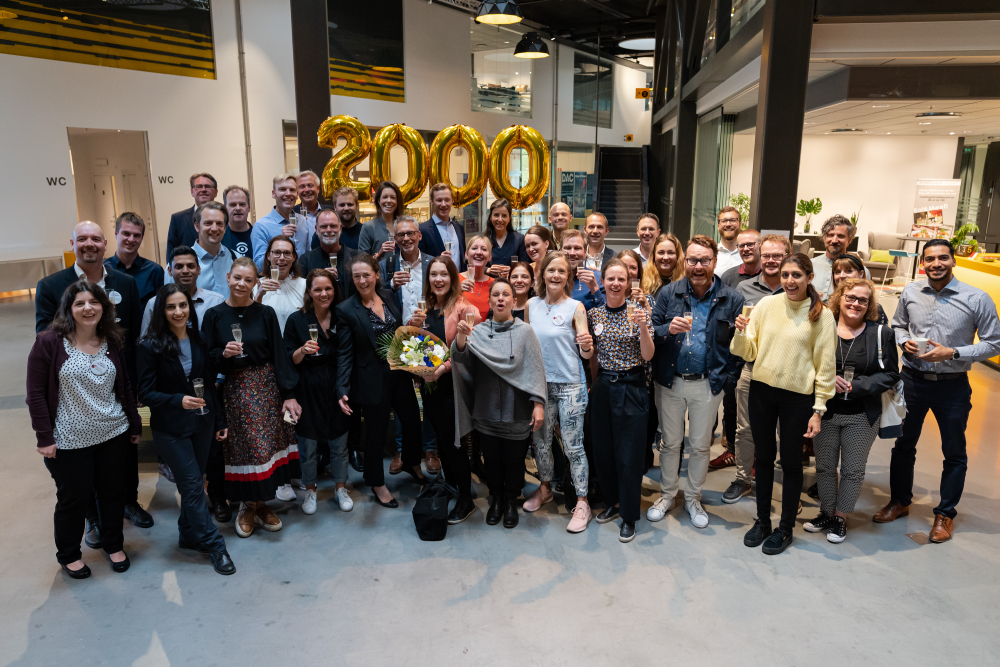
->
[202, 257, 302, 537]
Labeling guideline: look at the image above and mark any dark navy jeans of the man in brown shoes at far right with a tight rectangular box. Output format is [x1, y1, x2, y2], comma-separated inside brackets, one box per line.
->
[892, 371, 972, 519]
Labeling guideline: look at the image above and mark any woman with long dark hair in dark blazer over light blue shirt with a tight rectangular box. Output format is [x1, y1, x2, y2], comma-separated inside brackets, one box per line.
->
[136, 283, 236, 574]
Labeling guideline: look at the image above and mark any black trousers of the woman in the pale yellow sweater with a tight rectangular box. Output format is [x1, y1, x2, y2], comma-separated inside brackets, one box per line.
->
[747, 380, 814, 534]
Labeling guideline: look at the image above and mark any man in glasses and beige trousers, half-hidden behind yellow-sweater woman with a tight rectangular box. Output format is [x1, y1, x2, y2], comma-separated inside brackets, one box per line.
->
[722, 234, 792, 503]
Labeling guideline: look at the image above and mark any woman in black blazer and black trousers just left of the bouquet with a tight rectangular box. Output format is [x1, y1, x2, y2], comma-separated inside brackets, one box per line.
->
[335, 255, 427, 507]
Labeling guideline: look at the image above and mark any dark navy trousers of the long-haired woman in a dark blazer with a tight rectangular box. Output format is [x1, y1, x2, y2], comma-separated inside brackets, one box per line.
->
[153, 426, 226, 553]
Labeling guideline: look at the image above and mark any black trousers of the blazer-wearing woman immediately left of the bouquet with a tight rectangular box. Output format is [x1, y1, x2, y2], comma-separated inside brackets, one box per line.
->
[356, 368, 423, 486]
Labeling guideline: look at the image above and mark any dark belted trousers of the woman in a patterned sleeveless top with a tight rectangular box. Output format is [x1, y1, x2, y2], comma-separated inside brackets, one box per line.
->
[590, 373, 649, 523]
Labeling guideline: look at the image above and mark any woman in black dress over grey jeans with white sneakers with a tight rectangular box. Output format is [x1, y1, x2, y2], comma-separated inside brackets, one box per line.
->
[285, 269, 354, 514]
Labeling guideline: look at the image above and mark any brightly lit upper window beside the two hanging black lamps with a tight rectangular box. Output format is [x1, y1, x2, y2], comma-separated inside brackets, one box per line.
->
[469, 19, 532, 118]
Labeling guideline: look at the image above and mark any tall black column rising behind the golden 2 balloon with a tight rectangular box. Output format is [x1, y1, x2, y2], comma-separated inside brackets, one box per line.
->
[291, 0, 330, 183]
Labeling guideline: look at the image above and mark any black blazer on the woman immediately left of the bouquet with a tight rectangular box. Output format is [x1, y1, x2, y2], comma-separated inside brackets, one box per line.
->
[335, 289, 405, 409]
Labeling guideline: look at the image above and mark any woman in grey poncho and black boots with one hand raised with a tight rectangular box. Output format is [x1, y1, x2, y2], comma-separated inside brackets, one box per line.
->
[451, 278, 546, 528]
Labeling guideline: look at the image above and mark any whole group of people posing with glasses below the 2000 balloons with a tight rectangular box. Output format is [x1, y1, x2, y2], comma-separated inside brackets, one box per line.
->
[27, 172, 1000, 578]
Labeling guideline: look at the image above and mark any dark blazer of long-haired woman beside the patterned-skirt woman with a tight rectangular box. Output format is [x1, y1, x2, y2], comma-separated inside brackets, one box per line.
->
[136, 338, 226, 438]
